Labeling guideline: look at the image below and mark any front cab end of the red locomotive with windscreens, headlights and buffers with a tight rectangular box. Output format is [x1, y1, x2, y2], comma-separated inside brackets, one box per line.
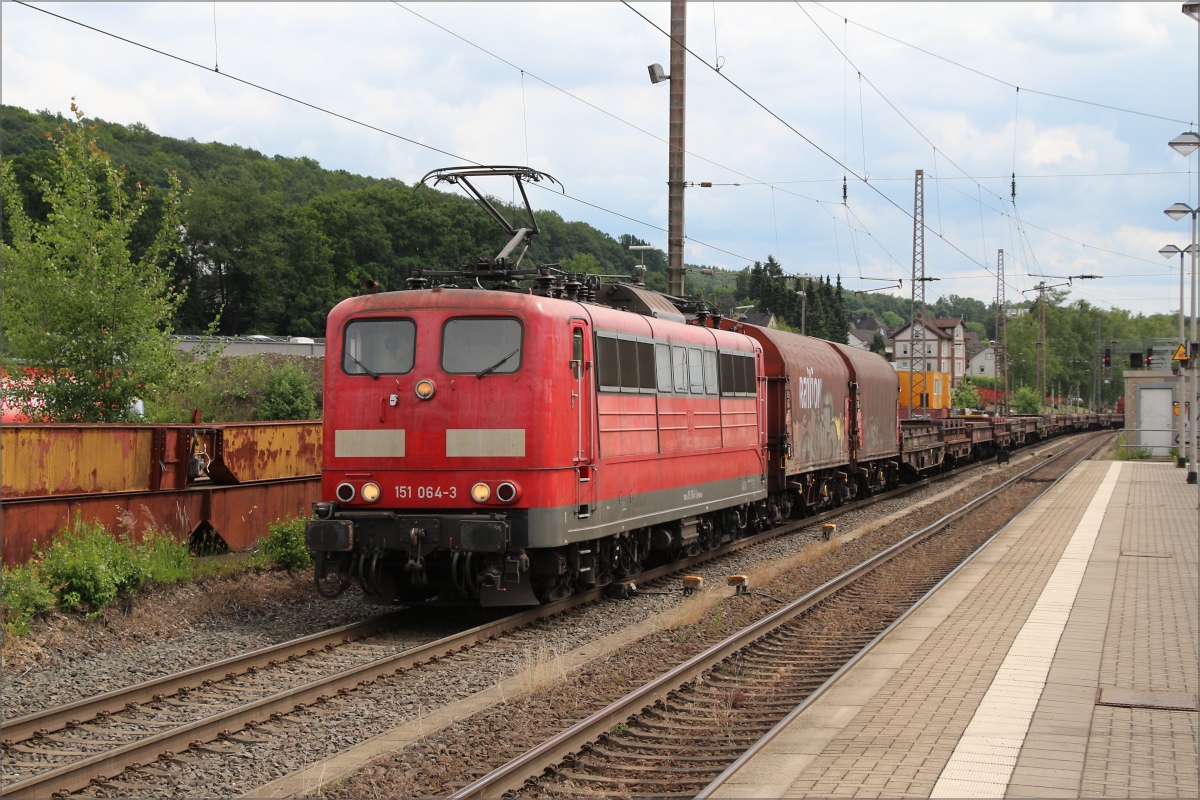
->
[306, 288, 595, 606]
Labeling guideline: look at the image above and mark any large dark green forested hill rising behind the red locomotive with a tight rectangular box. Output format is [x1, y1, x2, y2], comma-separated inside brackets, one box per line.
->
[0, 106, 676, 336]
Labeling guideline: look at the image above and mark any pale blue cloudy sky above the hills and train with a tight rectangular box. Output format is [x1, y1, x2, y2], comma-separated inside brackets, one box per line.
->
[0, 1, 1200, 313]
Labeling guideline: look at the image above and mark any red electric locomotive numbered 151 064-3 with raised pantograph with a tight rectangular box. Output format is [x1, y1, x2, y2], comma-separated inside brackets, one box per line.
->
[306, 168, 768, 606]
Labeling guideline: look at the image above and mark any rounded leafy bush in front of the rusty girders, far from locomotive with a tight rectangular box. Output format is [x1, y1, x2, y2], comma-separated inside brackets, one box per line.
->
[41, 517, 150, 609]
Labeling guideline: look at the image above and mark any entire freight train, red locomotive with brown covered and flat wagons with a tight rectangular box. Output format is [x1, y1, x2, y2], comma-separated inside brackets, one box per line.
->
[306, 168, 1114, 606]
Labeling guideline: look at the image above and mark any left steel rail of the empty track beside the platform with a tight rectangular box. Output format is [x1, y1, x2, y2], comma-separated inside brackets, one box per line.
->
[450, 434, 1104, 800]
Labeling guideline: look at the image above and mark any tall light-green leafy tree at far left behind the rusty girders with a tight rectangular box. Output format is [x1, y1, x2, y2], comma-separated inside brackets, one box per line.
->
[0, 102, 181, 422]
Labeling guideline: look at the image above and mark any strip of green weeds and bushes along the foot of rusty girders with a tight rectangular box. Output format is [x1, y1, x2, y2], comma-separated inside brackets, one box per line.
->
[0, 516, 311, 638]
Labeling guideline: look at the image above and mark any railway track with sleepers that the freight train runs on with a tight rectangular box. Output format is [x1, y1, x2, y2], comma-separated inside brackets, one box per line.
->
[0, 434, 1089, 796]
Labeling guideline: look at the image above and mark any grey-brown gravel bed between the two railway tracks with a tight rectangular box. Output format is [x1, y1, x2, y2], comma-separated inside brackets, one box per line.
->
[65, 438, 1099, 798]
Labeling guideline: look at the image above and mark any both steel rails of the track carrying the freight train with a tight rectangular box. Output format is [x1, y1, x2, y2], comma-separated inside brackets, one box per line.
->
[0, 434, 1089, 796]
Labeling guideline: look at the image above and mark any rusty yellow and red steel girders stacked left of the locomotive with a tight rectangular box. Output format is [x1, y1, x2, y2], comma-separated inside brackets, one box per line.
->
[0, 421, 322, 565]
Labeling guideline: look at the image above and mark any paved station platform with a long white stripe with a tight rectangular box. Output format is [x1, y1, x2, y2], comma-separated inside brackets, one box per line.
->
[713, 461, 1200, 798]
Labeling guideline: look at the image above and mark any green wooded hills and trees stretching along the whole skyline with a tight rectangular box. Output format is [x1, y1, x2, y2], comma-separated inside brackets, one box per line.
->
[0, 106, 1175, 407]
